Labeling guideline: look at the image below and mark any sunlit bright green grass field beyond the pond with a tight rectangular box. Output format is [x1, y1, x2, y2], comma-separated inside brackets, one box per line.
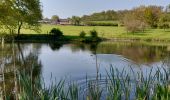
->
[19, 25, 170, 42]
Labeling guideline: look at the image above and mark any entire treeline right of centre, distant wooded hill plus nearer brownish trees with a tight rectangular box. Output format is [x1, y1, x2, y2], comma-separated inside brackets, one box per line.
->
[81, 5, 170, 32]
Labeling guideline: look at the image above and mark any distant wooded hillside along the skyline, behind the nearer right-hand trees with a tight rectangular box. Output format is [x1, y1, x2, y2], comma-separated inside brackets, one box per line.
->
[81, 5, 170, 21]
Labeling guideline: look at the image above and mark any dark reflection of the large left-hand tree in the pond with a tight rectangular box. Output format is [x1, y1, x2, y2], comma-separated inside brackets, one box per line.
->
[0, 44, 42, 97]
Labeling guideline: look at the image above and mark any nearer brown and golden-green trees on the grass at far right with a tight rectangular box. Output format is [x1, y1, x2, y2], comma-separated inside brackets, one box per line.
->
[120, 6, 170, 32]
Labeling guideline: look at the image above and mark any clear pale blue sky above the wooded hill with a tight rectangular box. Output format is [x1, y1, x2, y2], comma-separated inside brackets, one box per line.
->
[40, 0, 170, 18]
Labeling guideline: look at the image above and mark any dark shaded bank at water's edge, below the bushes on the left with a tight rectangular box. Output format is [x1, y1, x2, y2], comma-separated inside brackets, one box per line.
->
[0, 34, 102, 44]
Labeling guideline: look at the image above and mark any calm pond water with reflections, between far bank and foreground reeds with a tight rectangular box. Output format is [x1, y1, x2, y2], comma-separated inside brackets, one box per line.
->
[0, 42, 170, 98]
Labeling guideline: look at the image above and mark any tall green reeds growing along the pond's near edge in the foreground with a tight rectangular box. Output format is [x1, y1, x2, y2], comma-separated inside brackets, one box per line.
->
[2, 66, 170, 100]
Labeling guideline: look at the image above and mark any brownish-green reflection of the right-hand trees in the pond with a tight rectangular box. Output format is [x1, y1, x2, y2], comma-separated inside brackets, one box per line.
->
[97, 42, 170, 64]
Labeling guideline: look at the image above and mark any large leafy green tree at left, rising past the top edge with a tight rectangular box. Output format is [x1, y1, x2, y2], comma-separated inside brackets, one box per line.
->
[0, 0, 42, 35]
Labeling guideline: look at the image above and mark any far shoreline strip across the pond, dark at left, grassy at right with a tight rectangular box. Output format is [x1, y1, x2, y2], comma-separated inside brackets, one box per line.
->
[0, 34, 170, 43]
